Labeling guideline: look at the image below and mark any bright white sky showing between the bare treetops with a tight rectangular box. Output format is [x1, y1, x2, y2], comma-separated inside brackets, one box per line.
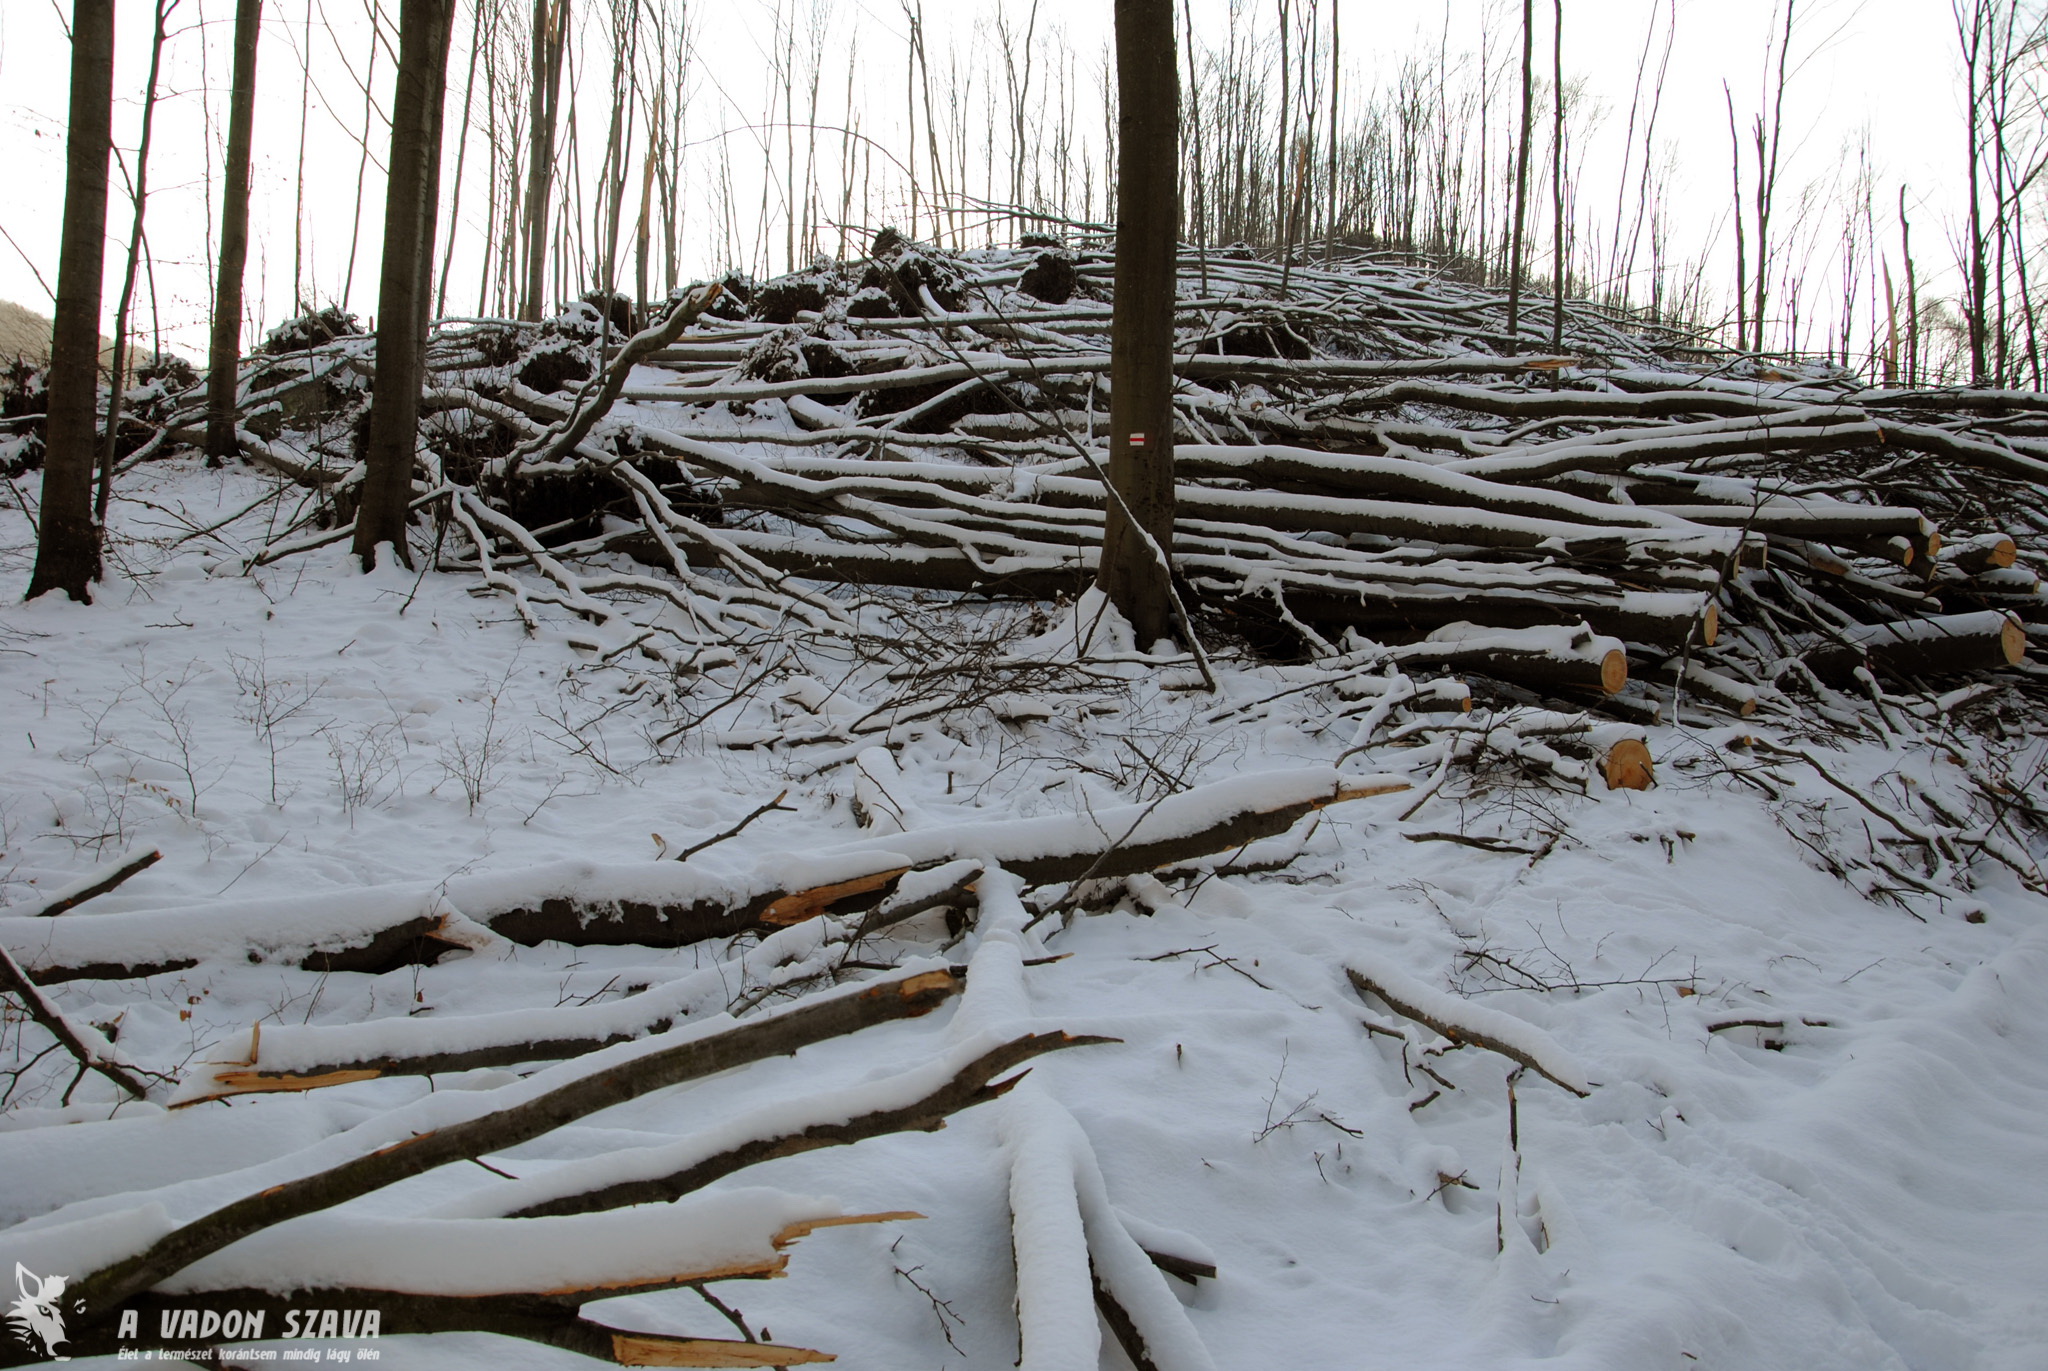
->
[0, 0, 1964, 357]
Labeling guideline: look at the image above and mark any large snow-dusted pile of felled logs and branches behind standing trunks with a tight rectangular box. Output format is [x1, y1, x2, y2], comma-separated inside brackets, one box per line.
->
[140, 232, 2048, 737]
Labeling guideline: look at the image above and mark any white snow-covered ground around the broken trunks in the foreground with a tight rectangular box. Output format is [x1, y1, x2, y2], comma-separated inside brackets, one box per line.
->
[0, 461, 2048, 1371]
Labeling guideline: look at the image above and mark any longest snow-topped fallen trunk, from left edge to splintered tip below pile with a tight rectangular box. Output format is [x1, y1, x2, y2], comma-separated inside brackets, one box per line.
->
[0, 768, 1407, 982]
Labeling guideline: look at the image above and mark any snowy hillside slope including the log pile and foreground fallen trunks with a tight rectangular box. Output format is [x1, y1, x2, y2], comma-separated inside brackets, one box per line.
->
[0, 240, 2048, 1371]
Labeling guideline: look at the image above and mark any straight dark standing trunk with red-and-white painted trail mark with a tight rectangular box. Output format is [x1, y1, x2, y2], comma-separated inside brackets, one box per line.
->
[1098, 0, 1180, 646]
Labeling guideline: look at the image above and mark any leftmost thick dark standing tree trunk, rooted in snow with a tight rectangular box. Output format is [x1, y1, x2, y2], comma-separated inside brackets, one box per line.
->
[29, 0, 115, 605]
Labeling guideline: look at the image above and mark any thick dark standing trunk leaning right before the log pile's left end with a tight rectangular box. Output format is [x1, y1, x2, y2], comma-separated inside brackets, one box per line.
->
[354, 0, 455, 570]
